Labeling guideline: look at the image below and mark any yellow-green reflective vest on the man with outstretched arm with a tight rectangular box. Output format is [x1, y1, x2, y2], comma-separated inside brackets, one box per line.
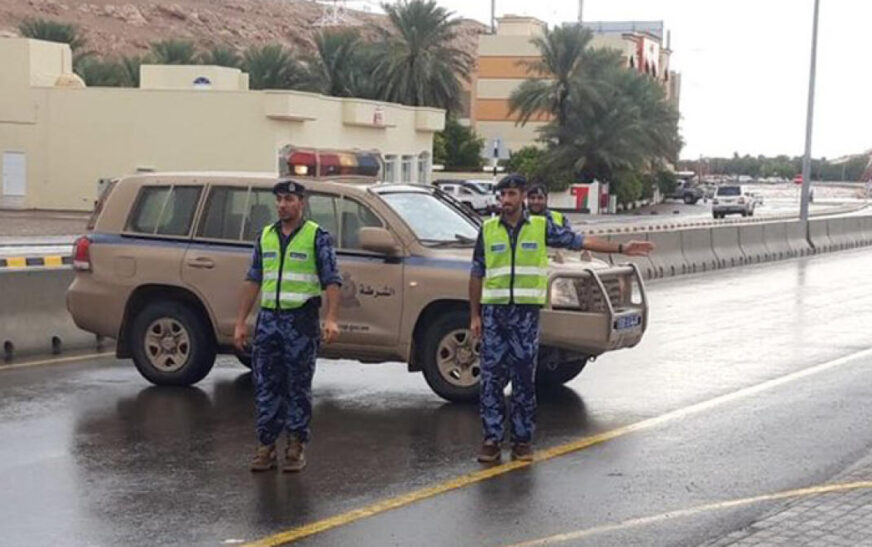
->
[481, 216, 548, 306]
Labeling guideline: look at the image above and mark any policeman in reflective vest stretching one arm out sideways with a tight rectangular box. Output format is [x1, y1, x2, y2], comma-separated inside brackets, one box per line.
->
[469, 175, 654, 463]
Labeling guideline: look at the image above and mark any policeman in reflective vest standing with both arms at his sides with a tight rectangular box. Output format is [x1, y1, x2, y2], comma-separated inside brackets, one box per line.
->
[233, 179, 342, 471]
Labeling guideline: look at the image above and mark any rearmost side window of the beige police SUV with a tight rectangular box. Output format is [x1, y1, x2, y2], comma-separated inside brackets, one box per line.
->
[127, 186, 202, 236]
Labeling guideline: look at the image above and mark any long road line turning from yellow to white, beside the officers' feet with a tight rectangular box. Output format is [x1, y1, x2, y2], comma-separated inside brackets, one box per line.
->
[247, 348, 872, 547]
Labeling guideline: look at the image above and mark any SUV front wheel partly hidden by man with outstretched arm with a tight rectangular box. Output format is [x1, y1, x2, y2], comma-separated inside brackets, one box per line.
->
[420, 310, 481, 403]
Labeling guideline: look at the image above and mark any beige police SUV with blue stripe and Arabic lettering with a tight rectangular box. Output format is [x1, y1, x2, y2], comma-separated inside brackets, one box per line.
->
[67, 173, 647, 401]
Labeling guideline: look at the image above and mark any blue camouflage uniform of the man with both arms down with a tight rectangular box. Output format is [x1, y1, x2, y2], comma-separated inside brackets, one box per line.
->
[246, 222, 342, 445]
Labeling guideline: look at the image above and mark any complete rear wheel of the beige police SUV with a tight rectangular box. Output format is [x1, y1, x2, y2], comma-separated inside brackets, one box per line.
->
[130, 300, 215, 386]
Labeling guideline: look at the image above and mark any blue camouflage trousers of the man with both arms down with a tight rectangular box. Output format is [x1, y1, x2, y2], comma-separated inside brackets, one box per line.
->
[251, 306, 320, 444]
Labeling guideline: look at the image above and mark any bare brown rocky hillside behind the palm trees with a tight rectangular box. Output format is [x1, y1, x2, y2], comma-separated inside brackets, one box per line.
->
[0, 0, 486, 60]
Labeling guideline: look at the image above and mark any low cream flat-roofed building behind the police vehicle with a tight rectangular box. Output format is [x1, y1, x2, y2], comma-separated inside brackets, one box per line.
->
[0, 38, 445, 210]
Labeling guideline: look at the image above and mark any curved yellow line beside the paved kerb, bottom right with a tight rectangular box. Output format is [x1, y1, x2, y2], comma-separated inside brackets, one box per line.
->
[500, 481, 872, 547]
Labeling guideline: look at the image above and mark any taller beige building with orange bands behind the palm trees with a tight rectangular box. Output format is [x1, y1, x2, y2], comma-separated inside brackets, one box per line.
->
[469, 15, 681, 158]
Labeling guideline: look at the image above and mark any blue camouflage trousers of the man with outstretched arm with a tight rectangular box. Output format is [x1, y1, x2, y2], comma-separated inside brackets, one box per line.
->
[479, 305, 539, 442]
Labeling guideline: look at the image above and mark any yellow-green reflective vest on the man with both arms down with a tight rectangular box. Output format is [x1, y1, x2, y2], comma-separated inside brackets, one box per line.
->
[260, 220, 321, 310]
